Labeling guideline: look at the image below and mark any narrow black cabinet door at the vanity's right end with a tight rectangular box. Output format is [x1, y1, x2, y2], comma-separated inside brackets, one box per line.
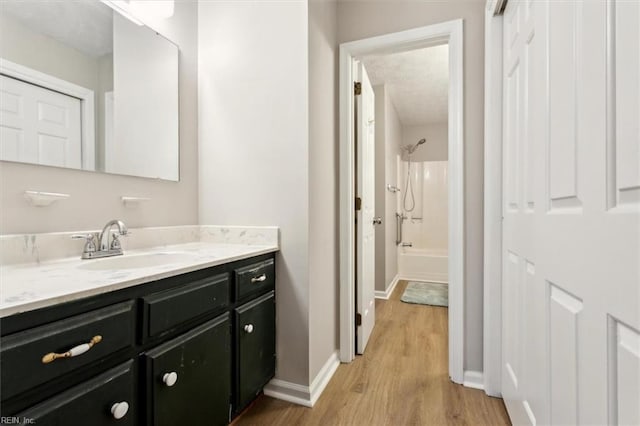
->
[235, 291, 276, 411]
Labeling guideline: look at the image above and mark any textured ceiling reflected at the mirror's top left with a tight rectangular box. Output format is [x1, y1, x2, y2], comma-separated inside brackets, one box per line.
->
[0, 0, 113, 57]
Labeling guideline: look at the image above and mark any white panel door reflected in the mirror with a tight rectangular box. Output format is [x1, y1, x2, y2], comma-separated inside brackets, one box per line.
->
[0, 75, 82, 169]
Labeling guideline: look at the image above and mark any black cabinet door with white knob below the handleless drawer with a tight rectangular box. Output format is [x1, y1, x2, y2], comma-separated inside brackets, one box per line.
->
[145, 314, 231, 426]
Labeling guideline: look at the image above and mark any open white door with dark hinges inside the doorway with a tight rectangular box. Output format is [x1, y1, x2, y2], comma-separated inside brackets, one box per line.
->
[356, 63, 376, 354]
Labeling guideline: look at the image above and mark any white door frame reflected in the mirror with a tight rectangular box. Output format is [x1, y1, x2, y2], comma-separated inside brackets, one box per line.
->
[0, 58, 96, 170]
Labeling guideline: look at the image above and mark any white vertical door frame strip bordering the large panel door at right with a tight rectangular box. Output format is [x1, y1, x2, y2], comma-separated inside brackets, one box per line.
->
[483, 0, 506, 396]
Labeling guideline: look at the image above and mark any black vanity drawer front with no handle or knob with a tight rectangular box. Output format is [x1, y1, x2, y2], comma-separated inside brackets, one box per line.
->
[143, 274, 229, 337]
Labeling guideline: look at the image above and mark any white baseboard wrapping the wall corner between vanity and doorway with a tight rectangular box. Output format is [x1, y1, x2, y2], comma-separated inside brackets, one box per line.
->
[264, 351, 340, 408]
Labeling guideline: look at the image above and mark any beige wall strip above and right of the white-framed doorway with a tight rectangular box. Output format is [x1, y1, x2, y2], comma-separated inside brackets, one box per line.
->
[338, 0, 484, 371]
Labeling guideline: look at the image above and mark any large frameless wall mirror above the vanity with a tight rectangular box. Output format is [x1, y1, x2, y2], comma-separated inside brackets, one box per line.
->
[0, 0, 179, 181]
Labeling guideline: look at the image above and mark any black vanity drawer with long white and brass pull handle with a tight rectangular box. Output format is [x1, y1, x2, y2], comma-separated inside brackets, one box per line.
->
[0, 301, 134, 399]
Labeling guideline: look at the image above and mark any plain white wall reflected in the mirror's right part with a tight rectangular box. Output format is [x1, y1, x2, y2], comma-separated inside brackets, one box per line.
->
[110, 13, 179, 180]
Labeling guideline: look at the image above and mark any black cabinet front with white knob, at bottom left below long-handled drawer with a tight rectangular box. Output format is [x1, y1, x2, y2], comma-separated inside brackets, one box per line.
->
[15, 361, 138, 426]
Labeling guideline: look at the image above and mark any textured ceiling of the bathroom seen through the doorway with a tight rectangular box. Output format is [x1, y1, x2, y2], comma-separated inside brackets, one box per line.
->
[362, 45, 449, 126]
